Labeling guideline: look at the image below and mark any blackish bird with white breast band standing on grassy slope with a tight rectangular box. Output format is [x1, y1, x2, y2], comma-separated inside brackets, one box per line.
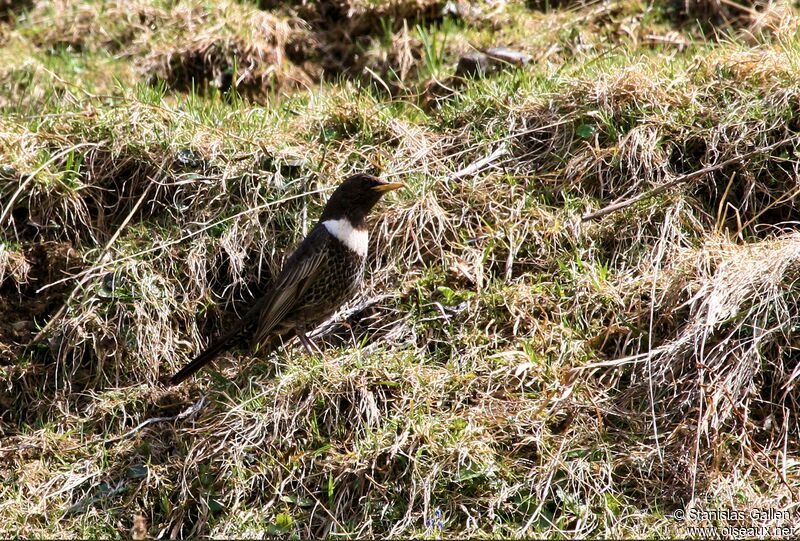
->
[171, 173, 403, 385]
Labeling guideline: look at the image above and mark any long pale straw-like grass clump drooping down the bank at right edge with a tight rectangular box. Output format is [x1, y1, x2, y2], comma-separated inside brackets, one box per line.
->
[626, 235, 797, 486]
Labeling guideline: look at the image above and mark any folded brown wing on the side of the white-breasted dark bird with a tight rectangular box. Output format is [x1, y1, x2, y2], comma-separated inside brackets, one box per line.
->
[254, 226, 328, 344]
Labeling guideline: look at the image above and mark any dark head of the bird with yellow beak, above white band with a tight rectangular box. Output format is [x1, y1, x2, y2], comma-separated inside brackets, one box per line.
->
[320, 173, 403, 228]
